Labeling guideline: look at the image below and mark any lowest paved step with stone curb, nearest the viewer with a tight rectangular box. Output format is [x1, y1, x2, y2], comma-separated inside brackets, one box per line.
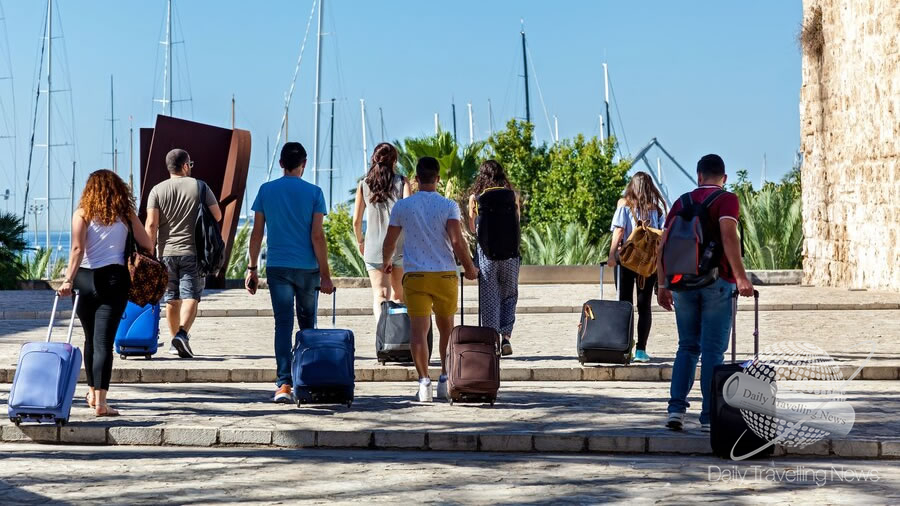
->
[0, 381, 900, 458]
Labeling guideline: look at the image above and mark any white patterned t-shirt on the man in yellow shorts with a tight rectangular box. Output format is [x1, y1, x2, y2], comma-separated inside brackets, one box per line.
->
[390, 191, 460, 272]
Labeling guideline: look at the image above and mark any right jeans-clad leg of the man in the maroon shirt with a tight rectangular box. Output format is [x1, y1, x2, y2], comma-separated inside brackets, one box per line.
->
[700, 279, 735, 424]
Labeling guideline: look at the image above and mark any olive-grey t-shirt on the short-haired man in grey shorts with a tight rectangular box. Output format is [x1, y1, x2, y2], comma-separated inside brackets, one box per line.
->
[147, 176, 218, 257]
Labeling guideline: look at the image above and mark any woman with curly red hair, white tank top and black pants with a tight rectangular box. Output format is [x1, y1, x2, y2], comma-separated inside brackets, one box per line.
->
[59, 170, 153, 416]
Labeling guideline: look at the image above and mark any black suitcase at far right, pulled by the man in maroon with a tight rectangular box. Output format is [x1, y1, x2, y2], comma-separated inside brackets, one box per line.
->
[709, 290, 775, 459]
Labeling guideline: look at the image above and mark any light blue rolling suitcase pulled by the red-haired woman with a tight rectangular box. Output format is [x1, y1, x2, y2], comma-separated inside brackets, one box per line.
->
[9, 292, 81, 427]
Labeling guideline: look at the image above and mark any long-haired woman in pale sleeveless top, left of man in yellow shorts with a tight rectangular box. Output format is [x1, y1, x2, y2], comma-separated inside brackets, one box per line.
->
[353, 142, 412, 322]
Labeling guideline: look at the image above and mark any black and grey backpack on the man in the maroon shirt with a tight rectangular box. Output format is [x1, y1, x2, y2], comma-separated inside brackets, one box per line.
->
[662, 189, 725, 291]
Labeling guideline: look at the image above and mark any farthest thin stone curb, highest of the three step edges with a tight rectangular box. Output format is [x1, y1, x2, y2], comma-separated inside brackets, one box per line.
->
[0, 302, 900, 321]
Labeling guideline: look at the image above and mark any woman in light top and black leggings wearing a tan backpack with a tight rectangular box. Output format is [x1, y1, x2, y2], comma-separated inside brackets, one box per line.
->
[607, 172, 666, 362]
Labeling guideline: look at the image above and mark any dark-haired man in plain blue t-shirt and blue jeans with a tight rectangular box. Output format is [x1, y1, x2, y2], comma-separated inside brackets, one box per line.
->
[245, 142, 334, 404]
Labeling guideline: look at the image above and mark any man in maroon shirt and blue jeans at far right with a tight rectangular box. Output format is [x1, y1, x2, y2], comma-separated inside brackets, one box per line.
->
[658, 155, 753, 432]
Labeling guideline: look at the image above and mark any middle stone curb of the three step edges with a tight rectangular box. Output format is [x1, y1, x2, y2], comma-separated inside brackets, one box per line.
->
[0, 364, 900, 384]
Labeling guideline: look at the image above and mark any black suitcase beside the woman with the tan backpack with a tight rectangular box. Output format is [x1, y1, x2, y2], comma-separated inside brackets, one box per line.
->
[576, 262, 634, 365]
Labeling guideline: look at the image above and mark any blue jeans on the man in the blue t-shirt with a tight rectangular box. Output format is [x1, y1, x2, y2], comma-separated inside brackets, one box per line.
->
[266, 267, 321, 387]
